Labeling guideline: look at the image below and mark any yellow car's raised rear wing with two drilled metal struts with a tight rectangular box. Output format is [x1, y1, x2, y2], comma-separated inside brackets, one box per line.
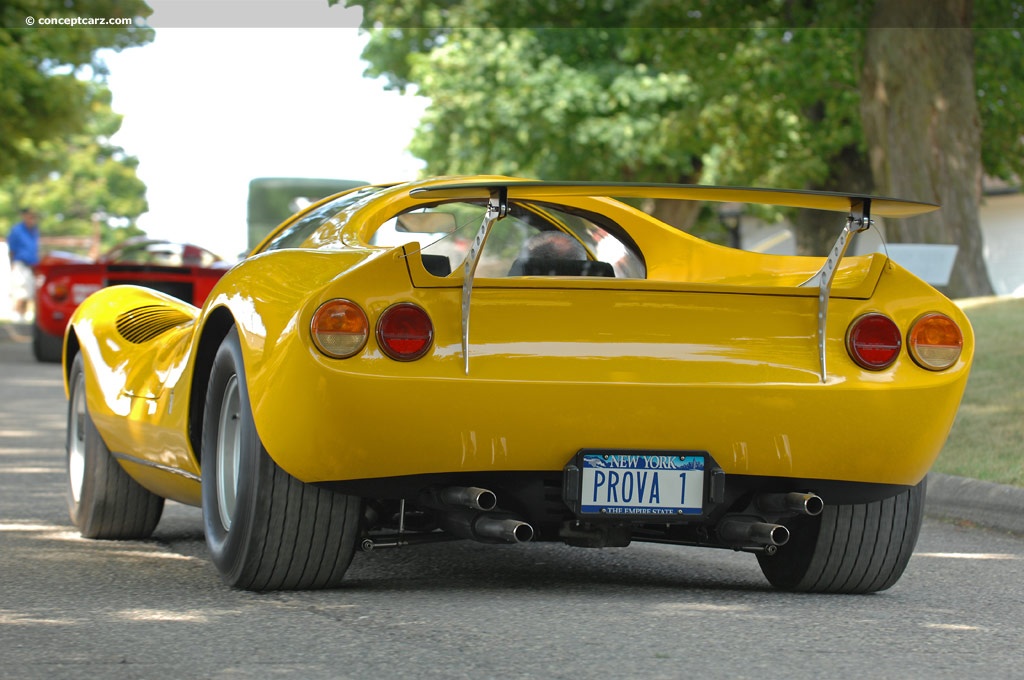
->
[410, 179, 939, 382]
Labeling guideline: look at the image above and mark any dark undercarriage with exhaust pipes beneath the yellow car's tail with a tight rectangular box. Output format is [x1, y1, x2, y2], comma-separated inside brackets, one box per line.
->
[324, 470, 907, 555]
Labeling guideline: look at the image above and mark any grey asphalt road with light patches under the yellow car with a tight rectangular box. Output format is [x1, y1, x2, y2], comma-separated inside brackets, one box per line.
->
[0, 328, 1024, 680]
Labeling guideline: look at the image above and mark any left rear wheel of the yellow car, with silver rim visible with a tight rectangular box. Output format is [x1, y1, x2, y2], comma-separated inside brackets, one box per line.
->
[202, 329, 362, 591]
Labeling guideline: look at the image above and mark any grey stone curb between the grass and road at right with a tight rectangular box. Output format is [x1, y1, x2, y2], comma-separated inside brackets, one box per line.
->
[925, 472, 1024, 535]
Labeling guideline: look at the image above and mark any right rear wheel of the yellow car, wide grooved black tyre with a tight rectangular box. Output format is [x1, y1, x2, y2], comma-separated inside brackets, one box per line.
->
[758, 480, 926, 593]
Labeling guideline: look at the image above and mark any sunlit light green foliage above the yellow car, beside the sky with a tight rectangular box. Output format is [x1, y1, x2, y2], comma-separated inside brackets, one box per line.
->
[348, 1, 705, 226]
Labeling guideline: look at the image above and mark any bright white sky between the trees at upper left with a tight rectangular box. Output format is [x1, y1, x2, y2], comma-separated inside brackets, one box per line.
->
[102, 0, 427, 257]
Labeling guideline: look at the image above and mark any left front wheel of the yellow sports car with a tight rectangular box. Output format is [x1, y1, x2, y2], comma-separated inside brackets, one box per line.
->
[67, 354, 164, 539]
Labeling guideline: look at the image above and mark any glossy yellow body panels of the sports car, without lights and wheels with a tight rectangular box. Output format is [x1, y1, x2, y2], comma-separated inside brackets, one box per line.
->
[67, 182, 974, 505]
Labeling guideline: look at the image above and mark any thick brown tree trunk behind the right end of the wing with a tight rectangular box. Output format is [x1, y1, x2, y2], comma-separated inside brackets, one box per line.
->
[860, 0, 993, 298]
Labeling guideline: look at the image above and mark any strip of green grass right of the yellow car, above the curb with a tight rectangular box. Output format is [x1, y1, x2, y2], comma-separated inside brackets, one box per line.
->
[934, 299, 1024, 486]
